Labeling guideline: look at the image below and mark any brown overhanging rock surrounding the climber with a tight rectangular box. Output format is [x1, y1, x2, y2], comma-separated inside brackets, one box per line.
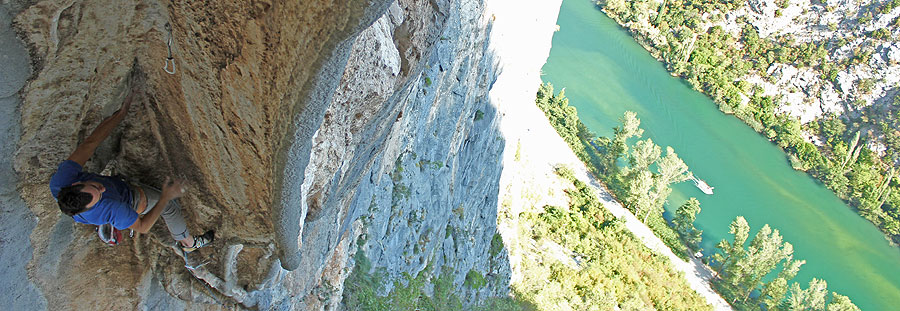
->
[4, 0, 388, 309]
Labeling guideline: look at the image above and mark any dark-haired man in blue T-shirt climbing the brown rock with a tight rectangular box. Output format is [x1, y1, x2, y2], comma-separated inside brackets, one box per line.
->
[50, 91, 215, 252]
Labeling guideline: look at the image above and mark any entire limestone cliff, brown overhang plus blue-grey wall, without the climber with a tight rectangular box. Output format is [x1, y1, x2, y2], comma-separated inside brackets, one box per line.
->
[0, 0, 540, 309]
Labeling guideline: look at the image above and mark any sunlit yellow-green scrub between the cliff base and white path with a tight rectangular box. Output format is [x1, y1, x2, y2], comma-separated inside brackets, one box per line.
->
[516, 168, 712, 310]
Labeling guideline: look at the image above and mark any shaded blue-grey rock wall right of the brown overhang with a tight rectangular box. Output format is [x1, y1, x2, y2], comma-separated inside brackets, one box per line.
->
[310, 1, 509, 304]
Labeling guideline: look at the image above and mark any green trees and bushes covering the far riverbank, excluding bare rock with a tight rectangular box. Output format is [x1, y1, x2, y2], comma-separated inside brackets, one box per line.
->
[598, 0, 900, 243]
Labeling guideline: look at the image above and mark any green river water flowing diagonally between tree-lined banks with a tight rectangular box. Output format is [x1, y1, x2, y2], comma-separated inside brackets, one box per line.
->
[543, 0, 900, 310]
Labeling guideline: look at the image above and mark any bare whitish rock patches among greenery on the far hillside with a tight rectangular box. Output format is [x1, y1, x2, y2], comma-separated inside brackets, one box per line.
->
[624, 0, 900, 123]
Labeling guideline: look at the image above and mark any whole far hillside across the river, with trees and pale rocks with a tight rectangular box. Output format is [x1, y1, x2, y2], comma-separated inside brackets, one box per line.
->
[598, 0, 900, 243]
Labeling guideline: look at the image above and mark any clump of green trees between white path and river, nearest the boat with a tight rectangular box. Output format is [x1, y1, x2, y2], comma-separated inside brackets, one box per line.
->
[536, 83, 691, 259]
